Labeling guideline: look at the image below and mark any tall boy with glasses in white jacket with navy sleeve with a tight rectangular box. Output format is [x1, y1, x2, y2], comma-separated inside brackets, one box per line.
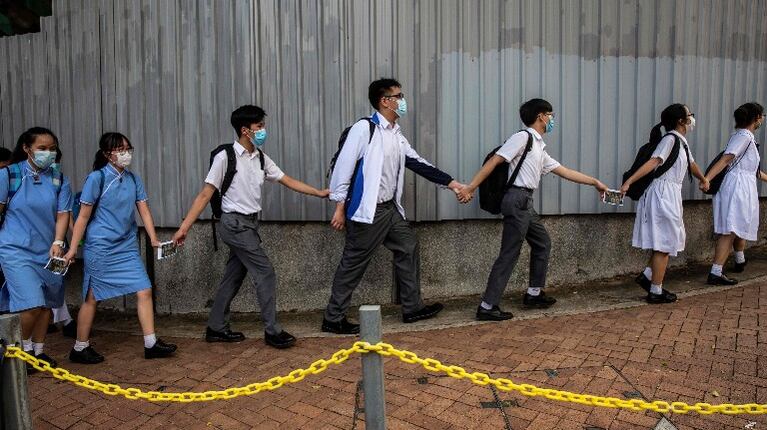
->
[322, 79, 461, 334]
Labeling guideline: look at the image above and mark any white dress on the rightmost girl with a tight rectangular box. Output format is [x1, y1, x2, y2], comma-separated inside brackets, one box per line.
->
[714, 129, 760, 241]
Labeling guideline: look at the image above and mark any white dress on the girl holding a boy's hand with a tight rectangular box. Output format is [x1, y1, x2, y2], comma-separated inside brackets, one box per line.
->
[631, 131, 695, 257]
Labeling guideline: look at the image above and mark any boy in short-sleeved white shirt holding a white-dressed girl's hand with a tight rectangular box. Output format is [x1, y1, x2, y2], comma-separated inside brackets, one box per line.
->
[460, 99, 607, 321]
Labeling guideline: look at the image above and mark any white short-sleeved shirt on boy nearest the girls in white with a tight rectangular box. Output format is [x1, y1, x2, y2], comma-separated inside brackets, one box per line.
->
[496, 128, 561, 190]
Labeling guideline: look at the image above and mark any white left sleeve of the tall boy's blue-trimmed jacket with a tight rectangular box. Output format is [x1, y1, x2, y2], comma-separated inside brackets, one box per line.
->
[329, 119, 370, 202]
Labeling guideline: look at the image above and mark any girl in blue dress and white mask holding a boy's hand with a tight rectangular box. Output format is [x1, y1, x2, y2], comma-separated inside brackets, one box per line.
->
[65, 133, 176, 364]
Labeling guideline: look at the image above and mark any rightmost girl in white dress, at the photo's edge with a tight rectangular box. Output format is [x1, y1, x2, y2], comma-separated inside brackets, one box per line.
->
[706, 103, 767, 285]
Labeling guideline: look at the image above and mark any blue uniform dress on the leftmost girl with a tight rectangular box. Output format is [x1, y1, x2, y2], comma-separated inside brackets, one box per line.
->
[0, 160, 72, 312]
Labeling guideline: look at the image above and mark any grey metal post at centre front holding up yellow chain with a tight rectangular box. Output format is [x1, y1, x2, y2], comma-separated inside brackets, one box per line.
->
[360, 305, 386, 430]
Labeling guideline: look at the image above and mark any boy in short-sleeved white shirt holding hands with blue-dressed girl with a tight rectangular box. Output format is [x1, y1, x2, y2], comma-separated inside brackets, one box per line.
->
[173, 105, 328, 348]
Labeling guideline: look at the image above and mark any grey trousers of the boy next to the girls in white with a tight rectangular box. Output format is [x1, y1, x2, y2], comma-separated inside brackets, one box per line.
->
[482, 187, 551, 306]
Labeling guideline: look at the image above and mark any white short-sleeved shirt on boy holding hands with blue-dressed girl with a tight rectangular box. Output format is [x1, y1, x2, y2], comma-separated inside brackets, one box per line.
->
[205, 141, 285, 215]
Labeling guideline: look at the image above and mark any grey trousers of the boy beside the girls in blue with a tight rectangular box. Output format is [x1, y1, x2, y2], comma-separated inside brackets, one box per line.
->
[208, 213, 282, 334]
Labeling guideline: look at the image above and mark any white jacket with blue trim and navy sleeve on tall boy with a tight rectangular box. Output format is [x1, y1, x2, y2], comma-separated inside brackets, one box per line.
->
[330, 112, 453, 224]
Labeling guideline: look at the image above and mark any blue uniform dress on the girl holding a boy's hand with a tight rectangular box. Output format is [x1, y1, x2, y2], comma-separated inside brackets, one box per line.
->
[80, 164, 151, 301]
